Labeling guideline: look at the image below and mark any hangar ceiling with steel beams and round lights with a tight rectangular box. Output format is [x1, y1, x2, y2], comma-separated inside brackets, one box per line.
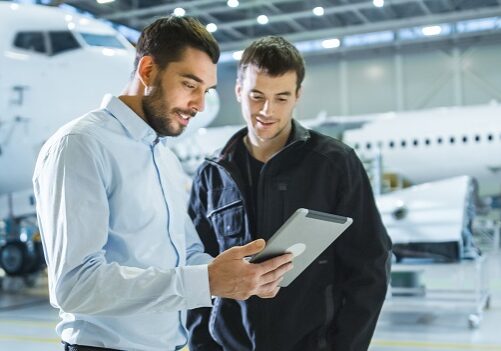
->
[56, 0, 501, 55]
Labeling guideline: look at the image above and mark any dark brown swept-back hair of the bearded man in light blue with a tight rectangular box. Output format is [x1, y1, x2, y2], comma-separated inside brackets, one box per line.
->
[134, 15, 220, 72]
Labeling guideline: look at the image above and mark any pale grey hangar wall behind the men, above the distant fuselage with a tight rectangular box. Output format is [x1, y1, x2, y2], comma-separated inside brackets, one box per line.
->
[212, 41, 501, 126]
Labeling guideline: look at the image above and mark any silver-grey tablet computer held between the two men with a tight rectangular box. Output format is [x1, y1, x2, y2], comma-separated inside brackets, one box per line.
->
[249, 208, 353, 287]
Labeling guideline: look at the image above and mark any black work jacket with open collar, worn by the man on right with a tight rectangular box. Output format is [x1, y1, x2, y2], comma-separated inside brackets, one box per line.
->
[187, 120, 391, 351]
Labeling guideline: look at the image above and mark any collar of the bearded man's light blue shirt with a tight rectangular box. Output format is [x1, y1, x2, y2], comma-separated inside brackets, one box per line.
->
[101, 94, 157, 143]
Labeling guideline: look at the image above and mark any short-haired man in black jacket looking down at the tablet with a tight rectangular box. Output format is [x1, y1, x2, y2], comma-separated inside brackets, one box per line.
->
[188, 37, 391, 351]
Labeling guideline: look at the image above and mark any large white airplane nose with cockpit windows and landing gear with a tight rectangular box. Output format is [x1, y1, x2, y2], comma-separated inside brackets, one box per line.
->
[0, 2, 219, 275]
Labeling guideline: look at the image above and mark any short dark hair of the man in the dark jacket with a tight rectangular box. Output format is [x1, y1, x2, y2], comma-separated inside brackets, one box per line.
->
[237, 36, 305, 90]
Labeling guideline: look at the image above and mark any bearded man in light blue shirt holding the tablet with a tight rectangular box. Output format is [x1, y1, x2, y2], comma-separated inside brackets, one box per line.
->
[33, 17, 291, 351]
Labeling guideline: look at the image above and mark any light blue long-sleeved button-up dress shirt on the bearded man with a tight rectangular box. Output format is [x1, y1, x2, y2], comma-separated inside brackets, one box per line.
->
[33, 95, 212, 351]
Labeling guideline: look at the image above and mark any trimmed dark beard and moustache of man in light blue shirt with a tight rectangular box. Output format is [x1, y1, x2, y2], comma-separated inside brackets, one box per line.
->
[141, 78, 196, 137]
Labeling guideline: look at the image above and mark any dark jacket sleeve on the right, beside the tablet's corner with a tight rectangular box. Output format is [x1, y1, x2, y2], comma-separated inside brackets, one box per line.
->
[333, 150, 391, 351]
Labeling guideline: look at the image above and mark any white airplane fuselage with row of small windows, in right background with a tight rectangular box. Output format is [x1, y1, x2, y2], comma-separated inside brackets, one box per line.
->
[343, 103, 501, 192]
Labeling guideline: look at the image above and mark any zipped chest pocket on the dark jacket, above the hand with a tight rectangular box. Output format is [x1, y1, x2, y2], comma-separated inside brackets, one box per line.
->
[208, 200, 245, 251]
